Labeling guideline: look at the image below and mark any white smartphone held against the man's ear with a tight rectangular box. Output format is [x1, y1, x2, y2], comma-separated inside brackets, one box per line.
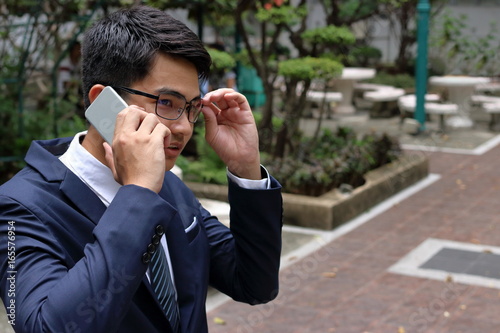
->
[85, 87, 128, 144]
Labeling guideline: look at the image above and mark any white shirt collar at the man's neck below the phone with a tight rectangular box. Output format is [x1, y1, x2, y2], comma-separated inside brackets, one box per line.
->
[59, 131, 121, 206]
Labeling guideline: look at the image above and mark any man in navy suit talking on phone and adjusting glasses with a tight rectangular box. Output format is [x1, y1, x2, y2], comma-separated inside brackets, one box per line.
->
[0, 6, 282, 333]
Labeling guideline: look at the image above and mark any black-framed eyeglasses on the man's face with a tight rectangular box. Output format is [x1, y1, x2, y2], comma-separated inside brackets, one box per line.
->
[113, 87, 203, 124]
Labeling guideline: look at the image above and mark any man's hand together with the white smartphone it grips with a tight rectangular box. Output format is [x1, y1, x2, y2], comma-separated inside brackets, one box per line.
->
[85, 87, 170, 193]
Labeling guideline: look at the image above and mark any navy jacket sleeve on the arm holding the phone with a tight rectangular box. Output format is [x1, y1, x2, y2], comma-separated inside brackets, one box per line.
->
[0, 185, 175, 333]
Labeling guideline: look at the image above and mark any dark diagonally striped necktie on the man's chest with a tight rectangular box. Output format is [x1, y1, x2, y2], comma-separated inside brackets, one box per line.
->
[149, 245, 180, 332]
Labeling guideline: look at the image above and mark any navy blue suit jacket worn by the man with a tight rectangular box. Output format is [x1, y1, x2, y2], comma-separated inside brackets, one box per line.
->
[0, 138, 282, 333]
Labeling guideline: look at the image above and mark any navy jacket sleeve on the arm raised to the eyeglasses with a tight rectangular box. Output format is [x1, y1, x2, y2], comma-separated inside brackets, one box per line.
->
[206, 177, 283, 304]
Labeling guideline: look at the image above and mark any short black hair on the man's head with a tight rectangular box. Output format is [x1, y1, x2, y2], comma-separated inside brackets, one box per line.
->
[82, 6, 212, 107]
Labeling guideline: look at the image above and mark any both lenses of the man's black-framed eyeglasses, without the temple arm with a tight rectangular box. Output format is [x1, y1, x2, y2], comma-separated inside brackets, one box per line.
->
[156, 93, 203, 123]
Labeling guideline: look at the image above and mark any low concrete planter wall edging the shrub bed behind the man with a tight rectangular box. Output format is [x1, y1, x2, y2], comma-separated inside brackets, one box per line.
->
[187, 153, 429, 230]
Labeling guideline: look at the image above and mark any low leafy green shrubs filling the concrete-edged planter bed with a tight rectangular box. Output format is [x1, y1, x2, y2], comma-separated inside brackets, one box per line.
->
[262, 127, 400, 196]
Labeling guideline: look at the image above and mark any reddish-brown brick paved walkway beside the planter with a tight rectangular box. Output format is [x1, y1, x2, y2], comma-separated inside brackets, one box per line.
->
[208, 146, 500, 333]
